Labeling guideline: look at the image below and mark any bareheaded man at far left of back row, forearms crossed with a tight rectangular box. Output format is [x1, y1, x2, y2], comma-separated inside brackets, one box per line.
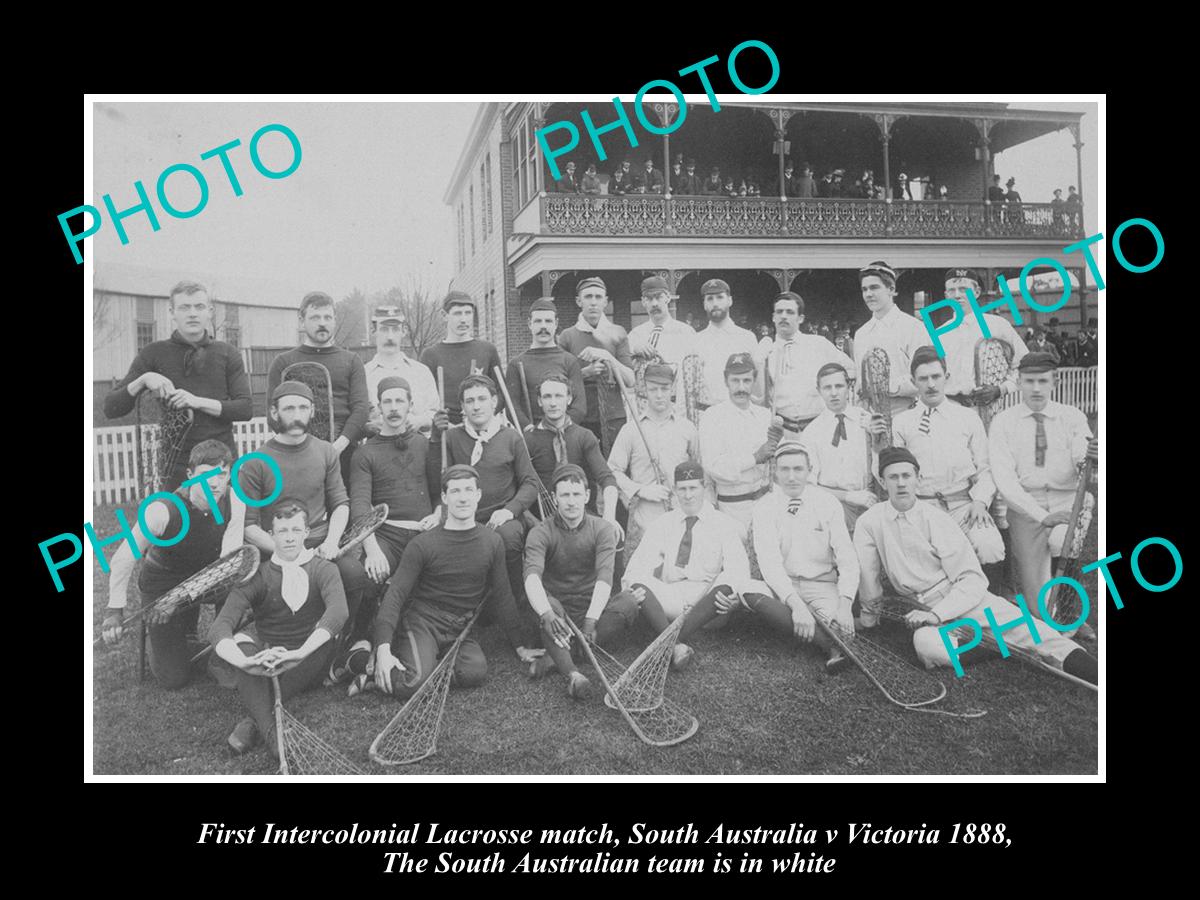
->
[104, 281, 253, 491]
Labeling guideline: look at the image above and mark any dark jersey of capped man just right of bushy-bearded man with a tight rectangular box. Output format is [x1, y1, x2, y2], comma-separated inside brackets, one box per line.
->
[350, 428, 440, 522]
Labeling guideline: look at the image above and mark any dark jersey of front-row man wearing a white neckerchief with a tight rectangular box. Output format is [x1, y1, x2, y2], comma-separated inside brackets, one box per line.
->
[209, 556, 349, 650]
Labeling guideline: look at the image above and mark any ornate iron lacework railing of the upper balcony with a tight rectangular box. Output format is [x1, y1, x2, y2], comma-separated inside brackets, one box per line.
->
[536, 193, 1084, 240]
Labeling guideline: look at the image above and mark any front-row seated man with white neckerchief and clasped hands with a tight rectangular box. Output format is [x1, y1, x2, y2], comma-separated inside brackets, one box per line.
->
[209, 499, 348, 757]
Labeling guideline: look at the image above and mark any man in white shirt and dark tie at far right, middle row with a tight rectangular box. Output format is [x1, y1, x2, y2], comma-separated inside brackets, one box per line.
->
[988, 350, 1098, 628]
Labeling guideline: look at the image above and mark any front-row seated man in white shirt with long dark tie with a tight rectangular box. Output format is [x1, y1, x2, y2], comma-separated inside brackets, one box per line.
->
[624, 461, 750, 668]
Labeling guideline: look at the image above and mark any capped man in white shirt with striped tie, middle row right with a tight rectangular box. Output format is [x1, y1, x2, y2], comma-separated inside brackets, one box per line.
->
[892, 347, 1004, 573]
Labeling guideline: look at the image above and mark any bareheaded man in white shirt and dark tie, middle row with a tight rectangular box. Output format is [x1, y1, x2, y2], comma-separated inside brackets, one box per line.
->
[804, 362, 887, 532]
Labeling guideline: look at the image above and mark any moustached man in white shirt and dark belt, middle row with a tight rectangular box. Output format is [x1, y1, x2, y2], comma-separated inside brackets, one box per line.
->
[700, 353, 784, 528]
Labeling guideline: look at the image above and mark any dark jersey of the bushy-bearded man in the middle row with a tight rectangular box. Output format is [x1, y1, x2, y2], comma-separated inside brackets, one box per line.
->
[238, 434, 350, 544]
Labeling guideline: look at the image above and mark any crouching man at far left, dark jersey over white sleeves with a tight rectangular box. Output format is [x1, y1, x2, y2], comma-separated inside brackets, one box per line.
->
[102, 440, 246, 690]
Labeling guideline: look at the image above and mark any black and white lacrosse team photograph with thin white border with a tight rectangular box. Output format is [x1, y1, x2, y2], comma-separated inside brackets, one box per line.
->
[82, 95, 1104, 781]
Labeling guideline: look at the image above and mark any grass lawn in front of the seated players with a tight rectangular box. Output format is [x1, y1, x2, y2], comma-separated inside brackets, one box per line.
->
[92, 508, 1097, 776]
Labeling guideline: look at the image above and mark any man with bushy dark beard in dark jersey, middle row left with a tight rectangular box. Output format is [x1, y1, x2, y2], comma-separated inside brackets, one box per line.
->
[238, 376, 367, 657]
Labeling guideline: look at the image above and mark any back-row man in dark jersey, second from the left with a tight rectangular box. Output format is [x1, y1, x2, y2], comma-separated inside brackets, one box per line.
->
[266, 290, 371, 493]
